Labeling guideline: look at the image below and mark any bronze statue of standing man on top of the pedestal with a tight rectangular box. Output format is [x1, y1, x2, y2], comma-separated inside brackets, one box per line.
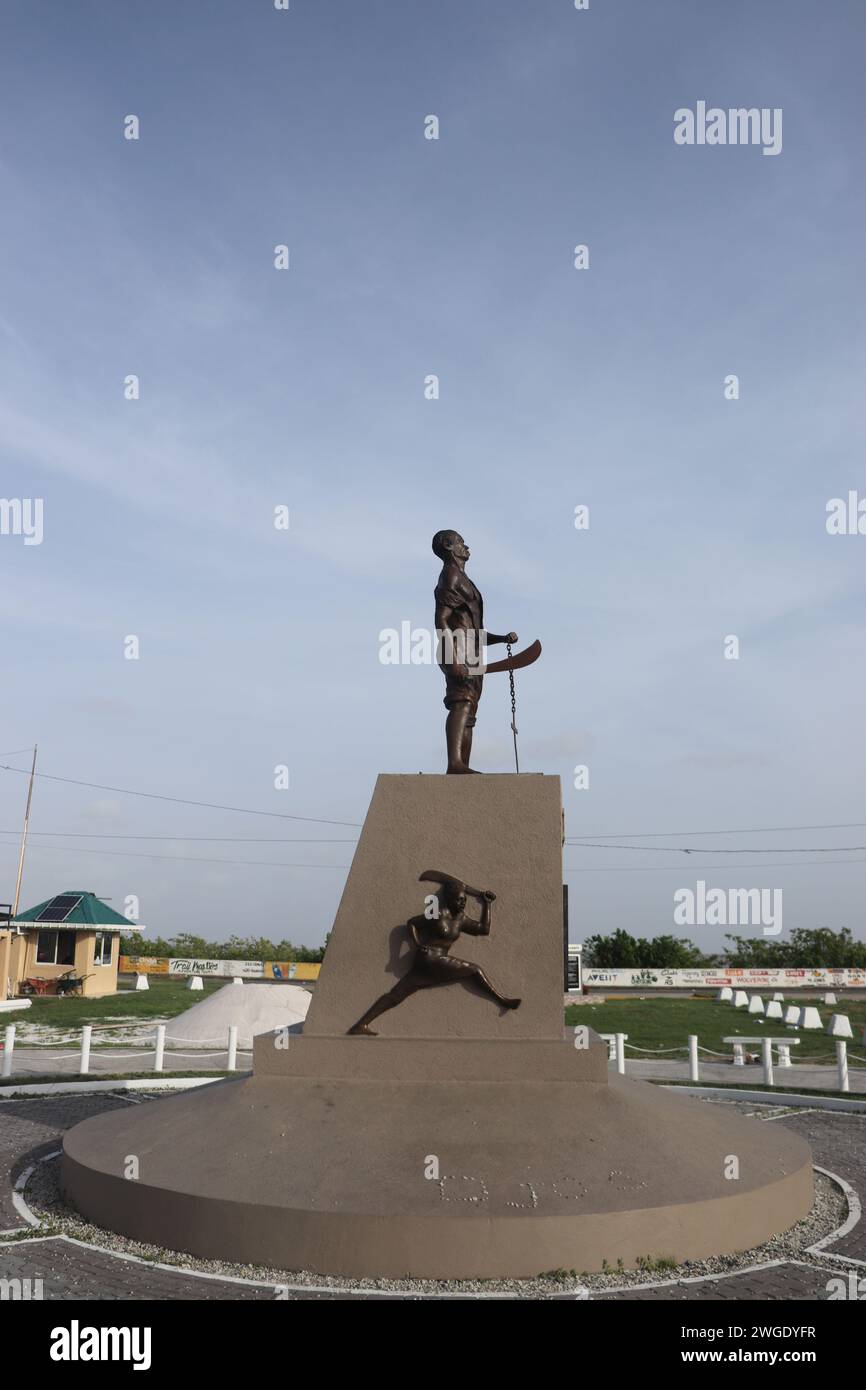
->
[432, 531, 517, 773]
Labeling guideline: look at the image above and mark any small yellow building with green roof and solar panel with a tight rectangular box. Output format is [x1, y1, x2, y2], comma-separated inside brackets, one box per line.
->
[0, 891, 129, 998]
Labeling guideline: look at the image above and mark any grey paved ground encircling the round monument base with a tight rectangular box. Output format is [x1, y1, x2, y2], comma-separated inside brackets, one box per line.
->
[0, 1094, 866, 1301]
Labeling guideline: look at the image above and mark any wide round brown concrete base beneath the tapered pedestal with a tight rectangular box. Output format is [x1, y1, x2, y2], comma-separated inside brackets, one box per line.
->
[63, 1076, 812, 1279]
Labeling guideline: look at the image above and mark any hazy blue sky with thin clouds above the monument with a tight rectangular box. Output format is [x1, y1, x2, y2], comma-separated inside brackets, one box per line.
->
[0, 0, 866, 949]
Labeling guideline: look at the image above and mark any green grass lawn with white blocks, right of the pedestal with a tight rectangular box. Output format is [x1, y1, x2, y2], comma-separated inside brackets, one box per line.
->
[566, 998, 866, 1066]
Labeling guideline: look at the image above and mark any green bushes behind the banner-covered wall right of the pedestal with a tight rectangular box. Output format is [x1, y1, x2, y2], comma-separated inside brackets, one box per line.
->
[584, 927, 866, 970]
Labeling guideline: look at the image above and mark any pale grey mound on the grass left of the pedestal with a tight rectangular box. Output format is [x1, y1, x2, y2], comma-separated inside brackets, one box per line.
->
[165, 983, 313, 1051]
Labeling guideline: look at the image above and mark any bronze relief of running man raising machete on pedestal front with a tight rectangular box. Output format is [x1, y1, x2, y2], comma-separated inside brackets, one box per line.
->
[349, 869, 520, 1037]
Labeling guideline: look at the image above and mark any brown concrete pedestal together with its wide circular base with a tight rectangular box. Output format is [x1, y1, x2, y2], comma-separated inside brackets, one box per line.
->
[63, 777, 812, 1279]
